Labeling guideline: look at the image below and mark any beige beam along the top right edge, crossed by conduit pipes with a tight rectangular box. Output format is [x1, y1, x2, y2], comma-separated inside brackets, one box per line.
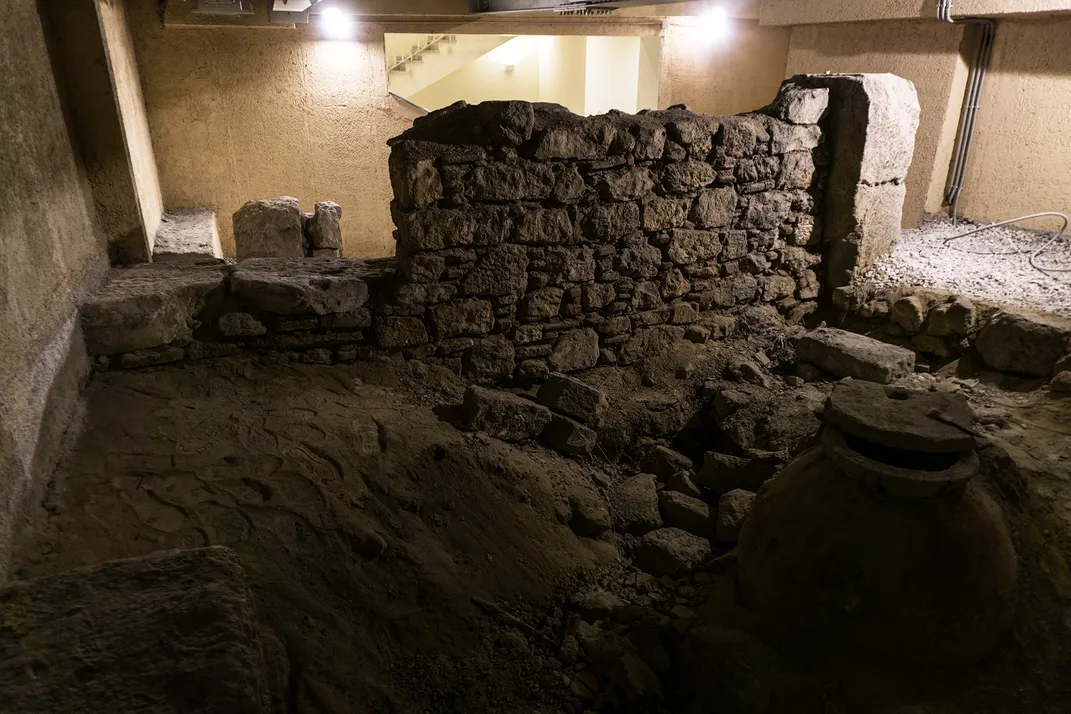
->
[759, 0, 1071, 25]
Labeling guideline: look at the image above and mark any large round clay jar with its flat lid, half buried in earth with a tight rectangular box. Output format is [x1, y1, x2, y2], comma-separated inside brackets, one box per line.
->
[738, 380, 1017, 665]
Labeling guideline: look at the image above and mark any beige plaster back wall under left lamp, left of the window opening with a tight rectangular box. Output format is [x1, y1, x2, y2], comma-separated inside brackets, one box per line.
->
[126, 0, 411, 257]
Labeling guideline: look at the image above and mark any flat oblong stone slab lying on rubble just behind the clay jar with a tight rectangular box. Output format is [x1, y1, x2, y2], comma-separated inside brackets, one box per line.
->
[796, 328, 915, 384]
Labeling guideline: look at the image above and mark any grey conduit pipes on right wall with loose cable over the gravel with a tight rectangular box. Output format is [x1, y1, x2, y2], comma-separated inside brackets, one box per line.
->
[937, 0, 1071, 274]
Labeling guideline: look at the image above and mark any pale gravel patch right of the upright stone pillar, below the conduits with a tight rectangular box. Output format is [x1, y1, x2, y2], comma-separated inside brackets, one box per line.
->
[861, 219, 1071, 316]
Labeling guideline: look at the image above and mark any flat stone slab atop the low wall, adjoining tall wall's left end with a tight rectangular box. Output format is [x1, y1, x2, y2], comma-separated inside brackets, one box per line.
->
[230, 258, 393, 315]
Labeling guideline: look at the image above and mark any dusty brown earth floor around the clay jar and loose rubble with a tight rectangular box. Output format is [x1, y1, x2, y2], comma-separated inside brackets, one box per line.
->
[8, 336, 1071, 714]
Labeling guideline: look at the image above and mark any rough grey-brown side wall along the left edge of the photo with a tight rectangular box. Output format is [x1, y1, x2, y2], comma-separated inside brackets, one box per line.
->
[0, 0, 106, 577]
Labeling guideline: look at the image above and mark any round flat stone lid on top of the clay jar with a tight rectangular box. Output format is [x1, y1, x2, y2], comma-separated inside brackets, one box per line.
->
[824, 379, 975, 454]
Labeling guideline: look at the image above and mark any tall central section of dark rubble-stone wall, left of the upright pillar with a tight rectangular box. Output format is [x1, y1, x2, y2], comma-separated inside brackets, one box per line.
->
[375, 86, 829, 379]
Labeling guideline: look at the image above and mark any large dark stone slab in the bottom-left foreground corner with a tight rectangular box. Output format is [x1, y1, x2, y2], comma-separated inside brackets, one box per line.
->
[0, 547, 269, 714]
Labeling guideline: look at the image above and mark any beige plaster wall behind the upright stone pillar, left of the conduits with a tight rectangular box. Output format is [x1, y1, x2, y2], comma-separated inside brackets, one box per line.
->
[788, 20, 966, 227]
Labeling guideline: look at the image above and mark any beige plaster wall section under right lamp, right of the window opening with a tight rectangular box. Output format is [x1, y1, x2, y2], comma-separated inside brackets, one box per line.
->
[659, 19, 791, 116]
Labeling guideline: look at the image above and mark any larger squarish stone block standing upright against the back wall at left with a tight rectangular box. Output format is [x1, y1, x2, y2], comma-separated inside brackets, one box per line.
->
[232, 196, 305, 260]
